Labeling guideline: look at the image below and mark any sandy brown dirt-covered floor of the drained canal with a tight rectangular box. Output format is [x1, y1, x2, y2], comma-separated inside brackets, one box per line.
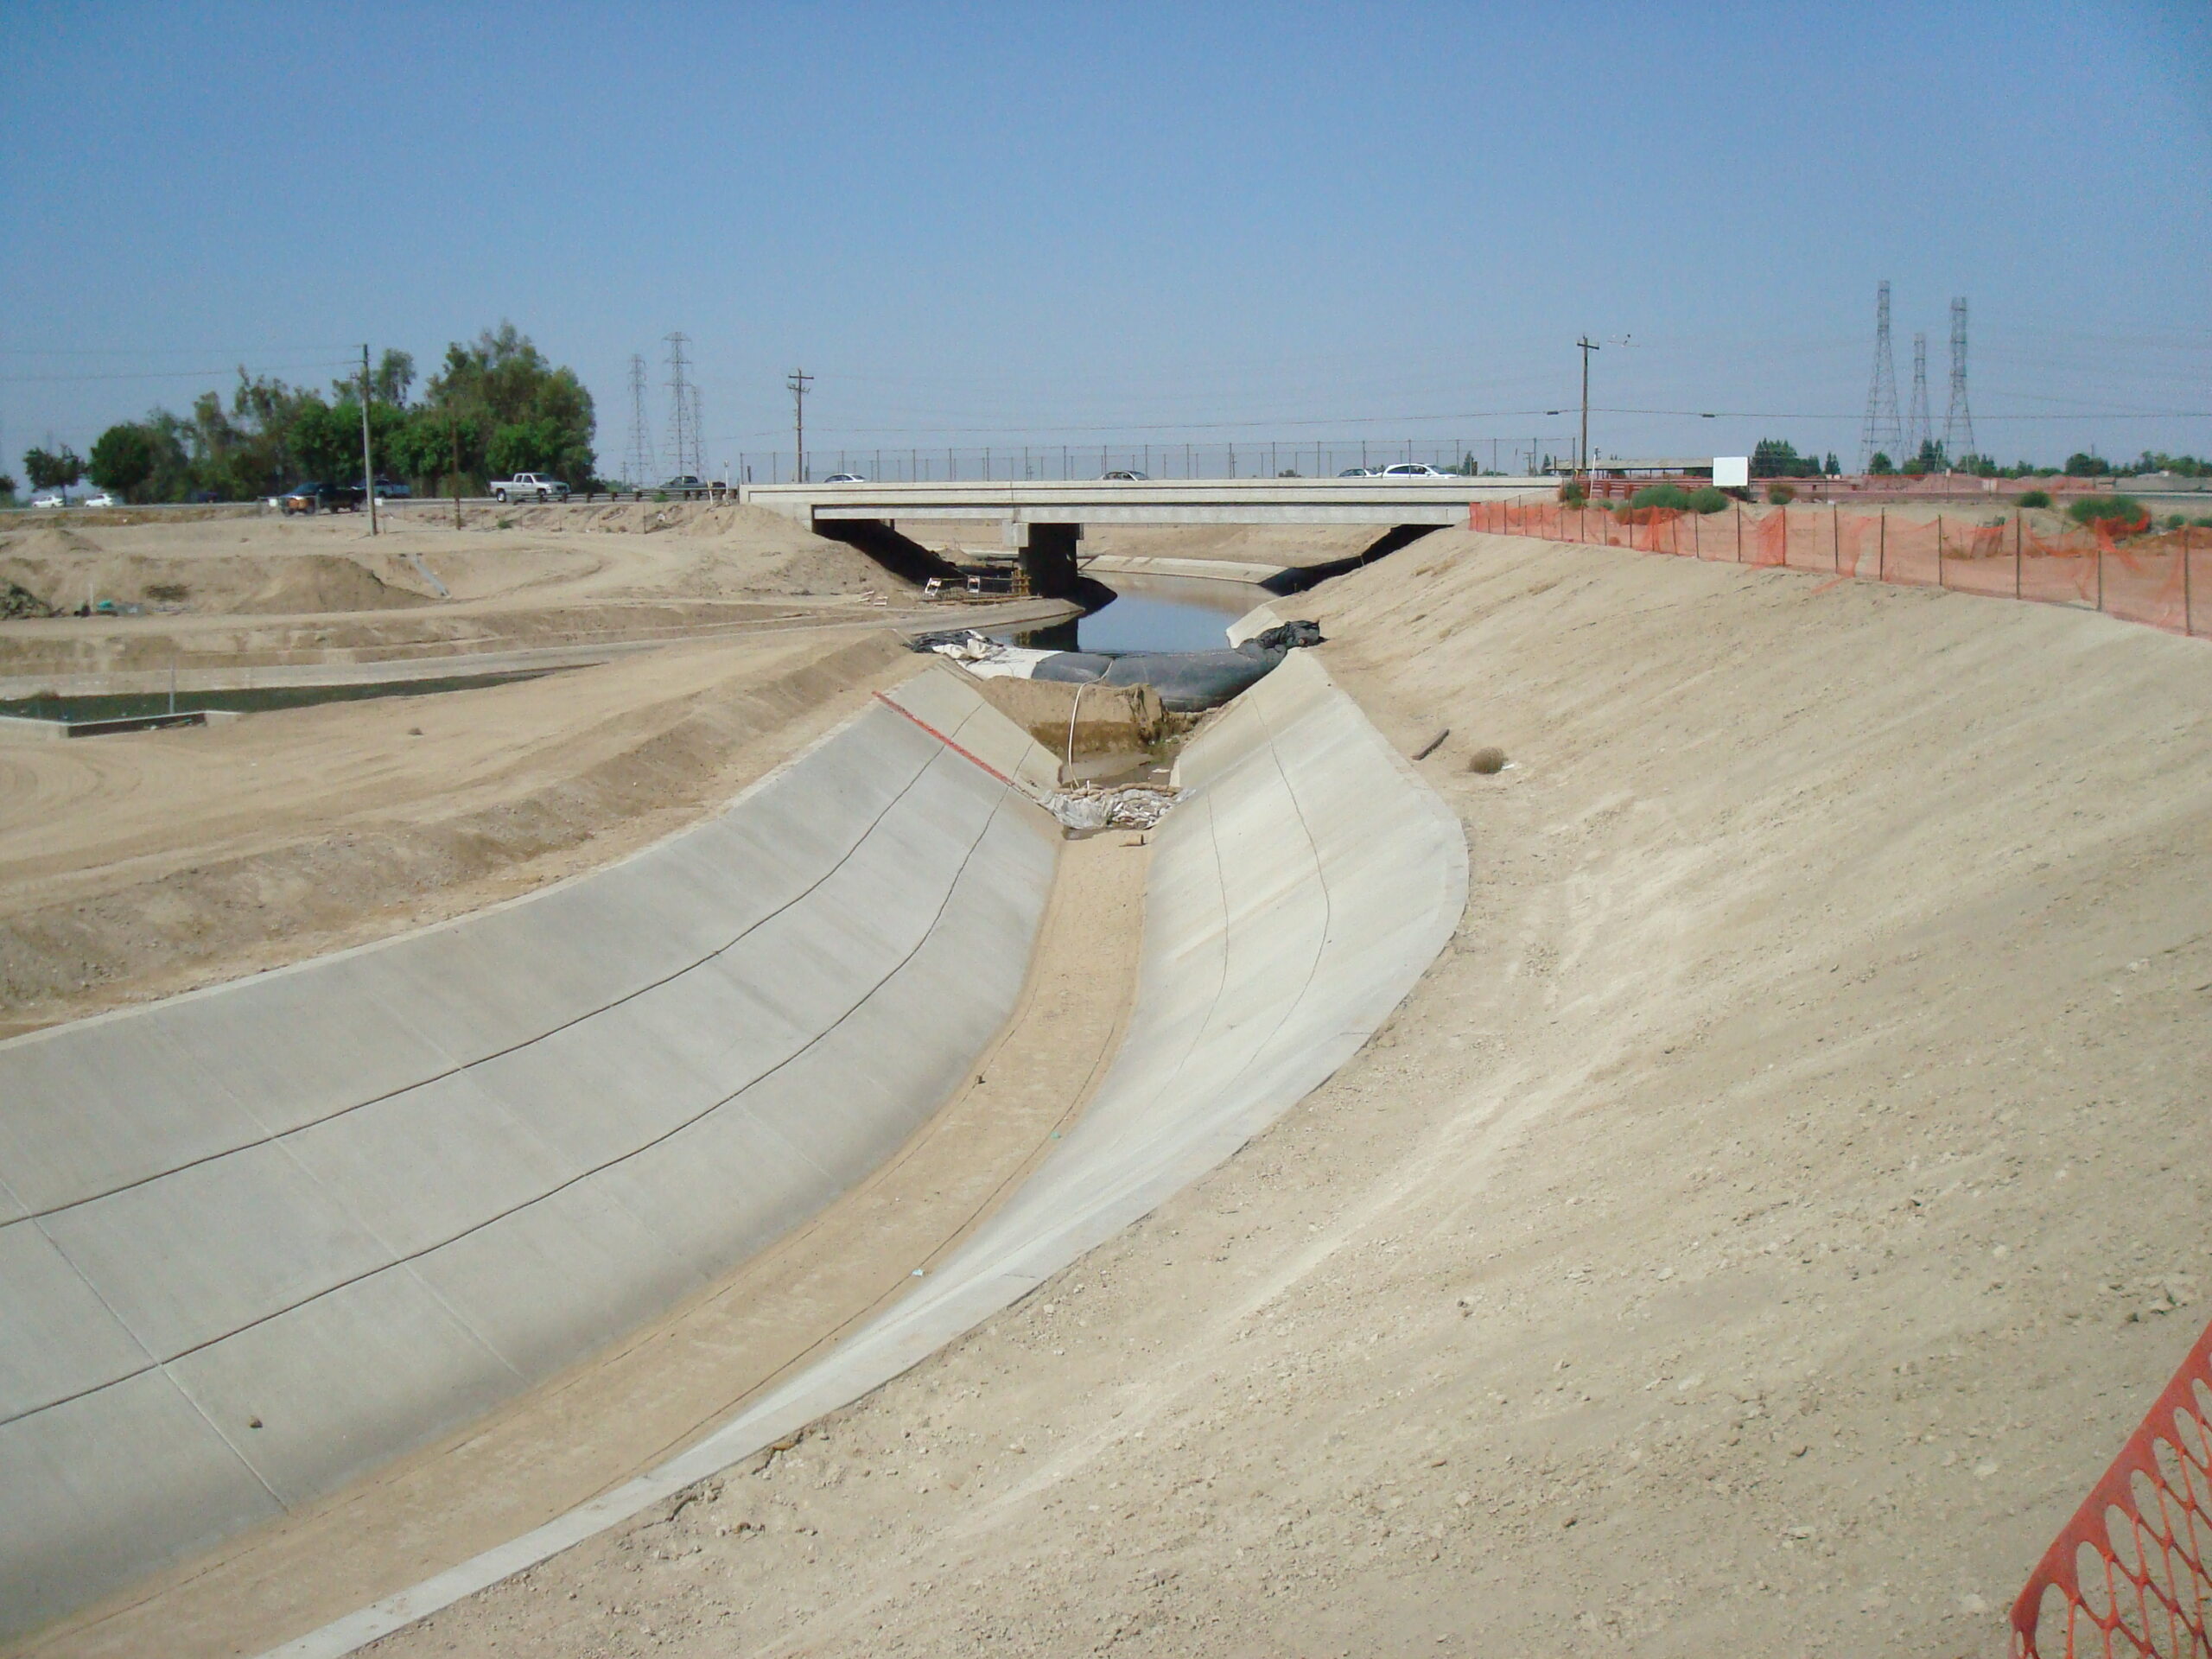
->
[9, 832, 1150, 1659]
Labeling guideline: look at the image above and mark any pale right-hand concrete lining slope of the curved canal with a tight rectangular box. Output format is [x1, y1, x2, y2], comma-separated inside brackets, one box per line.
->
[254, 645, 1466, 1659]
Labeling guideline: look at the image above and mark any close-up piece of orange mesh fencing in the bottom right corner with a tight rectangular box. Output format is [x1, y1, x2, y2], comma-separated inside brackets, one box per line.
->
[2013, 1327, 2212, 1659]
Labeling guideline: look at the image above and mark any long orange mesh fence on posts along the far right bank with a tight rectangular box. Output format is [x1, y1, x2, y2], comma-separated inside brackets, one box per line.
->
[1466, 502, 2212, 635]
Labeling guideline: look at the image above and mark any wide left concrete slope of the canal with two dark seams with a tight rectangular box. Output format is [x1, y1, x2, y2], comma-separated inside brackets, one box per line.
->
[0, 675, 1058, 1630]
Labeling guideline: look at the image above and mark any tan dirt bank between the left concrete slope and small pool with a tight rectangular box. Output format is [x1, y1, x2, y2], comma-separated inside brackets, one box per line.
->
[0, 631, 913, 1035]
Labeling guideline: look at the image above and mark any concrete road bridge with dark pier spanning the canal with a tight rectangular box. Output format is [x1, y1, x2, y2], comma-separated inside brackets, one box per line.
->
[739, 478, 1555, 595]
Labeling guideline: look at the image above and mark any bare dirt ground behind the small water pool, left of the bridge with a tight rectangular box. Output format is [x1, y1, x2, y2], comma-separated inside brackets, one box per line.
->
[0, 505, 913, 681]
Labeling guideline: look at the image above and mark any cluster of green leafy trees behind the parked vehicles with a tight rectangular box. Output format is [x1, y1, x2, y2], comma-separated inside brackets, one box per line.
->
[84, 323, 597, 502]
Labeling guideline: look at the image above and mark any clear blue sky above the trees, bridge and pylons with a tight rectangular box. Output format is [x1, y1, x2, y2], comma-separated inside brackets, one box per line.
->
[0, 0, 2212, 469]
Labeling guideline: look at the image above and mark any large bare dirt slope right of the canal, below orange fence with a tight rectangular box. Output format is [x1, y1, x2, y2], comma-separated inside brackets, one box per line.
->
[353, 531, 2212, 1659]
